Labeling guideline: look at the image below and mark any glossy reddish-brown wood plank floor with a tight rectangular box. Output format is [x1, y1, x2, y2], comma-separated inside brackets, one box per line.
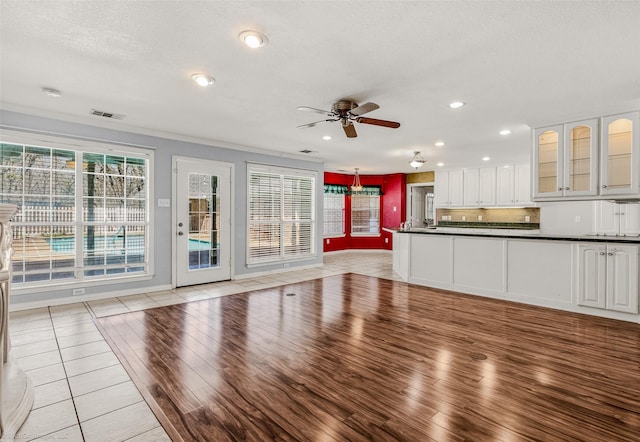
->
[96, 273, 640, 441]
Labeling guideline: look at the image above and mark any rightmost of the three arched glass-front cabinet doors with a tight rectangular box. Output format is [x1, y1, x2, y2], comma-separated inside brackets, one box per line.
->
[600, 112, 640, 196]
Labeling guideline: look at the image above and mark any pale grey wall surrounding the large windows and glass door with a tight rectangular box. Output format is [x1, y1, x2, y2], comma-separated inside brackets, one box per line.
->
[0, 110, 324, 304]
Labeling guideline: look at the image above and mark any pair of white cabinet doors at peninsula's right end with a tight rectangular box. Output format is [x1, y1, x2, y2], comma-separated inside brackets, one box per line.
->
[575, 243, 640, 314]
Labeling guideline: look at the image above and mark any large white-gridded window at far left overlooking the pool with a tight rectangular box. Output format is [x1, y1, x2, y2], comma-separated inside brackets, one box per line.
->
[0, 142, 150, 287]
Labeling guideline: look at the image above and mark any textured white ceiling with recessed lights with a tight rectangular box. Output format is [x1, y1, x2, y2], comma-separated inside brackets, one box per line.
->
[0, 0, 640, 174]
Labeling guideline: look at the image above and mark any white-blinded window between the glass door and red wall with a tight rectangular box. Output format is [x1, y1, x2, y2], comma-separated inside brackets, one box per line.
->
[247, 165, 315, 264]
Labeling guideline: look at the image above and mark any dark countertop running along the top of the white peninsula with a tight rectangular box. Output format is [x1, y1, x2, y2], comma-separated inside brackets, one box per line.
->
[387, 227, 640, 244]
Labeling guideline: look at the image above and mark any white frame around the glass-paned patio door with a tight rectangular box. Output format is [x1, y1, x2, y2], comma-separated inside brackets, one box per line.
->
[172, 155, 235, 288]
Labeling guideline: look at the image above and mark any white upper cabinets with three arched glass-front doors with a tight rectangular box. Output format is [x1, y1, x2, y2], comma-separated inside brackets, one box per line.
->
[532, 112, 640, 201]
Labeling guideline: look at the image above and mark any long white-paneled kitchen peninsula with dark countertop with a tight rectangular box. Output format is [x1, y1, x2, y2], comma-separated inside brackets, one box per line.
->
[393, 227, 640, 323]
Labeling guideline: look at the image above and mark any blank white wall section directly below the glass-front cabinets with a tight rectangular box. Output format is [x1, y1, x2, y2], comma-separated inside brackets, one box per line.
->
[539, 201, 596, 235]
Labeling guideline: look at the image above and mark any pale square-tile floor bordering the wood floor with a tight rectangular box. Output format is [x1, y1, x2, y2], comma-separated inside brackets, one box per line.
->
[10, 251, 399, 442]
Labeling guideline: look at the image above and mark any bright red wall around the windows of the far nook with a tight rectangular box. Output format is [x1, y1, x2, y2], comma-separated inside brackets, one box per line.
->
[322, 172, 407, 252]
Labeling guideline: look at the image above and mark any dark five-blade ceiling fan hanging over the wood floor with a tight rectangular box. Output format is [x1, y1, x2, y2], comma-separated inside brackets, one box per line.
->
[298, 100, 400, 138]
